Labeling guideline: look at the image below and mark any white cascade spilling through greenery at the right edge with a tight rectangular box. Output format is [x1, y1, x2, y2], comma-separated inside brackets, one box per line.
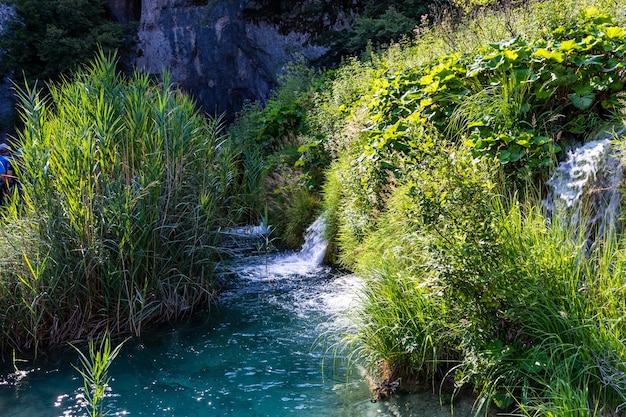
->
[544, 132, 623, 239]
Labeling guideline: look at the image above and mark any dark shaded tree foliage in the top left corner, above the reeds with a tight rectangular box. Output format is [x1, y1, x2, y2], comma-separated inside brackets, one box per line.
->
[0, 0, 125, 82]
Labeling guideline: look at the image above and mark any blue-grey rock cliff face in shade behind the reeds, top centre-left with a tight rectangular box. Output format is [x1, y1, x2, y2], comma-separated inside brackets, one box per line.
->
[129, 0, 325, 116]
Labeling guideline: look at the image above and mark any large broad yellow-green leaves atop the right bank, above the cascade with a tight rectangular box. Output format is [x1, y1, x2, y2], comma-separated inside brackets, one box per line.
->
[360, 8, 626, 177]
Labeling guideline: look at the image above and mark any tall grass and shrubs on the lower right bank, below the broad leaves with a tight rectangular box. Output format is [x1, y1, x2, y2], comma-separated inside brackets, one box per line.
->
[348, 172, 626, 416]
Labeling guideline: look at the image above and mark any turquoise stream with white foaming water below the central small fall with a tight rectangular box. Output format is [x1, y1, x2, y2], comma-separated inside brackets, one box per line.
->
[0, 219, 471, 417]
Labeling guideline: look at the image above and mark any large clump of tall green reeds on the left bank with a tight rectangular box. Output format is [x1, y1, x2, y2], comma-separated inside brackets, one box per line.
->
[0, 53, 241, 353]
